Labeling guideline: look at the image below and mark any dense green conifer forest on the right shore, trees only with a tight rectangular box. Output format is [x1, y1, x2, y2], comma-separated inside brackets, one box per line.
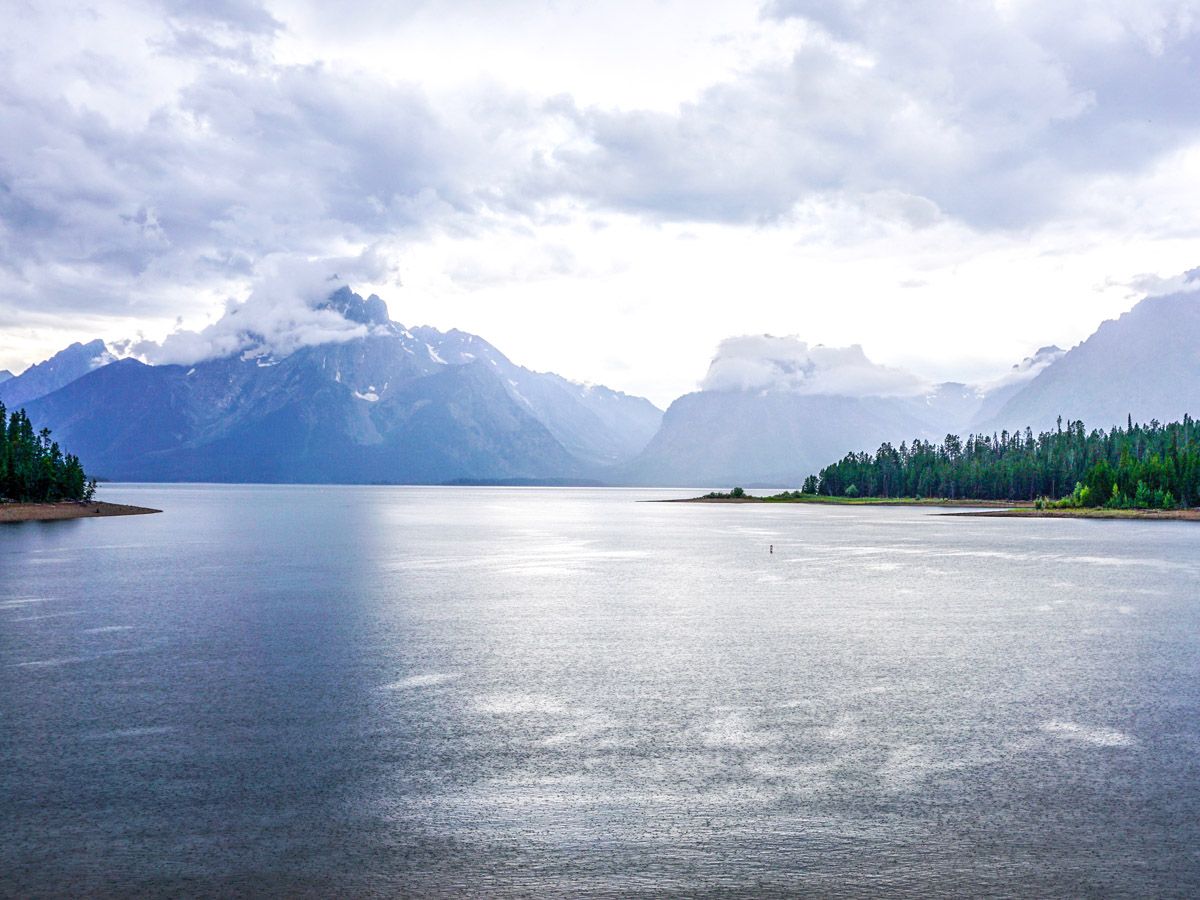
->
[805, 415, 1200, 509]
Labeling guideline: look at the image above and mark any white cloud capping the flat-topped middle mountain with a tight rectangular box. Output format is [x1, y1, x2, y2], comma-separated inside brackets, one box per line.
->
[701, 335, 932, 397]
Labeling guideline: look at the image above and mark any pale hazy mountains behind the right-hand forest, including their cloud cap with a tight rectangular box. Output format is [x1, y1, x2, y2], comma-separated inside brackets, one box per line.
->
[618, 293, 1200, 486]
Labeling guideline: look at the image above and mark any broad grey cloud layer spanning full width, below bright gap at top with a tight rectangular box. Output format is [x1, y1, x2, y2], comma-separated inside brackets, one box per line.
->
[9, 0, 1200, 310]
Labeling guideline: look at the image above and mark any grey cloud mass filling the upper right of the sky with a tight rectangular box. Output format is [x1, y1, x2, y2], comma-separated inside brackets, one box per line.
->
[547, 0, 1200, 228]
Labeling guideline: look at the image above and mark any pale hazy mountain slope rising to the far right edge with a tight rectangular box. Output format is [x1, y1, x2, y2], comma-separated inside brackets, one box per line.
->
[978, 293, 1200, 431]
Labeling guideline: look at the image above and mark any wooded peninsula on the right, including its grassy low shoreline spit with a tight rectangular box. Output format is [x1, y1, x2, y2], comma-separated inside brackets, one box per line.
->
[685, 415, 1200, 521]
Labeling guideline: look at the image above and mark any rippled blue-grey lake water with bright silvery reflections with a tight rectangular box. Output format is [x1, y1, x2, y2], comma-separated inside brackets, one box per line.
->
[0, 485, 1200, 896]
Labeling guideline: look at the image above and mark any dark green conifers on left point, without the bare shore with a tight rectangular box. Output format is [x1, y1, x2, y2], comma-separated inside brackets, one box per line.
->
[0, 403, 96, 503]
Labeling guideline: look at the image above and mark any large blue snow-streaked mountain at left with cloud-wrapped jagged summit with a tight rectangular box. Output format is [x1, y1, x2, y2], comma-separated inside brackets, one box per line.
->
[18, 287, 661, 484]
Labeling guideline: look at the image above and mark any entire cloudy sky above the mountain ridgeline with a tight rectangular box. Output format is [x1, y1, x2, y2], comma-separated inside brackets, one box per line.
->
[0, 0, 1200, 404]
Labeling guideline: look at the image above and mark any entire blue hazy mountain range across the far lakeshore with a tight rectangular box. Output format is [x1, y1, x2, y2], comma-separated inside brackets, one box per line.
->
[0, 288, 1200, 486]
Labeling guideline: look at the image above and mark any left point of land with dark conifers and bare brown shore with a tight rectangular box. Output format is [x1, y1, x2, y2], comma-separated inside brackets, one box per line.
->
[0, 403, 162, 522]
